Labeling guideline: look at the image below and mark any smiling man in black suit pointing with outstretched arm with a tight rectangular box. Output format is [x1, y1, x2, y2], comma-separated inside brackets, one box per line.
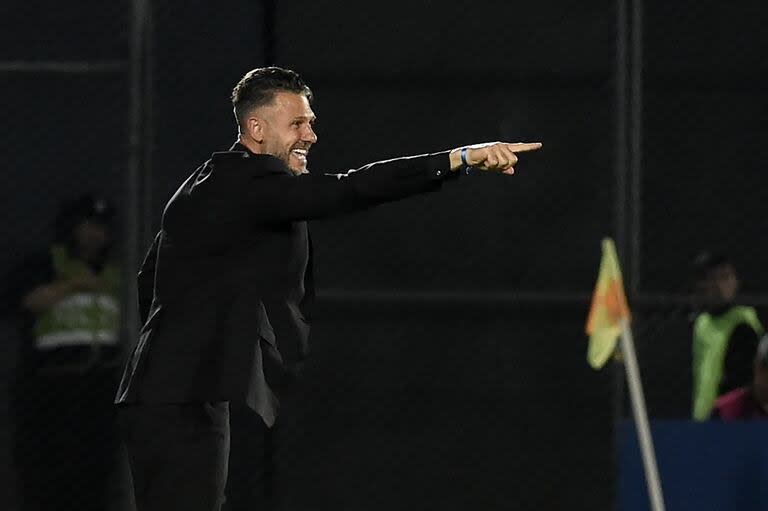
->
[116, 67, 541, 511]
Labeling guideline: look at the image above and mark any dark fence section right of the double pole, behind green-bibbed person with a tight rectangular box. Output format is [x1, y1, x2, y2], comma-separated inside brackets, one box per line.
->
[635, 2, 768, 424]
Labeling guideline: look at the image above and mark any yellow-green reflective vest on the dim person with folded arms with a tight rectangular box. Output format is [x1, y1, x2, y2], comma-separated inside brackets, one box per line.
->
[34, 245, 120, 350]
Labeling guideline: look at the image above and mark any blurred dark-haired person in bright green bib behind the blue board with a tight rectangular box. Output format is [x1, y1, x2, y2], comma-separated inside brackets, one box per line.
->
[692, 252, 764, 421]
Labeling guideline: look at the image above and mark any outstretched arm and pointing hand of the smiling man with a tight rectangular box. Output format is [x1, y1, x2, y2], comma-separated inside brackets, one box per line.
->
[165, 142, 541, 239]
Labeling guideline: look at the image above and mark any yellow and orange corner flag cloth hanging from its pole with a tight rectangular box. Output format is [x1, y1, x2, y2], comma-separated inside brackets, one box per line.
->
[587, 238, 630, 369]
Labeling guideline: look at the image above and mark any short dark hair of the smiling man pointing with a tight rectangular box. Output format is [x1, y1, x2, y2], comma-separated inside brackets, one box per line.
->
[232, 66, 312, 126]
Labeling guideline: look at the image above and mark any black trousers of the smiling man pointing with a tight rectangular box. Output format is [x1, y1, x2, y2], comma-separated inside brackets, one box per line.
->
[120, 401, 230, 511]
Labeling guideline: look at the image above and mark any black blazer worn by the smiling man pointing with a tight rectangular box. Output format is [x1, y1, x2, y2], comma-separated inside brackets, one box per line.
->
[115, 144, 458, 425]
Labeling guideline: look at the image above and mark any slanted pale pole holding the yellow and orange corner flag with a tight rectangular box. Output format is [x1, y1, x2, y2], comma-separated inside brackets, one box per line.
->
[621, 318, 665, 511]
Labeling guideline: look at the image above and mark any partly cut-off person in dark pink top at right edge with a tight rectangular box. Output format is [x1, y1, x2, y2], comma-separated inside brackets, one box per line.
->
[712, 335, 768, 422]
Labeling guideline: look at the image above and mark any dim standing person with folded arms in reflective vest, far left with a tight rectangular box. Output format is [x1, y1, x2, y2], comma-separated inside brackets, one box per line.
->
[8, 195, 122, 511]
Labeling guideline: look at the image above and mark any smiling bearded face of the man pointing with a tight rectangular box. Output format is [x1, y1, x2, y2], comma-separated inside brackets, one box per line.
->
[246, 91, 317, 175]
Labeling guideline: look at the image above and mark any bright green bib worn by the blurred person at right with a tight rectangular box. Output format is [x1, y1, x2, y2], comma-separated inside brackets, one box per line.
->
[693, 306, 764, 421]
